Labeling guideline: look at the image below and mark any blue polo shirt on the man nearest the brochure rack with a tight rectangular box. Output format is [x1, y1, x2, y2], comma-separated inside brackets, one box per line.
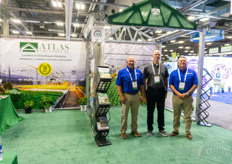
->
[116, 66, 144, 93]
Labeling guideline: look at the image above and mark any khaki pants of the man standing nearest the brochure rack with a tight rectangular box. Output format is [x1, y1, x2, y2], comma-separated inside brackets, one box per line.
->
[121, 93, 140, 132]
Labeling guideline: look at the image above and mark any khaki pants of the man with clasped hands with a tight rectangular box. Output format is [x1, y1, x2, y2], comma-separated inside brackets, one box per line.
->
[172, 95, 193, 134]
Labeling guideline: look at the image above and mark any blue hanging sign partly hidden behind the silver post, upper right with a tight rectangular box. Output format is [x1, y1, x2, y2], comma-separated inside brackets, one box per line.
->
[190, 29, 224, 42]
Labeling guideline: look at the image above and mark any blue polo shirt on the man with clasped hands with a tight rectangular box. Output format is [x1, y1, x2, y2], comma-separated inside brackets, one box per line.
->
[169, 68, 198, 94]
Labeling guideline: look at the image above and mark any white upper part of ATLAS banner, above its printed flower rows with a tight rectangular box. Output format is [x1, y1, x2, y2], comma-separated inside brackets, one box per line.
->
[0, 39, 86, 84]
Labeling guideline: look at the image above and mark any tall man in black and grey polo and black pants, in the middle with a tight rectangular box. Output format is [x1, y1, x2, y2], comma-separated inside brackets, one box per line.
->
[143, 50, 169, 137]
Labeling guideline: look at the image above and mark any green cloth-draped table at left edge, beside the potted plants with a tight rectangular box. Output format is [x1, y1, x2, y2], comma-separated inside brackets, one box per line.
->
[0, 96, 23, 134]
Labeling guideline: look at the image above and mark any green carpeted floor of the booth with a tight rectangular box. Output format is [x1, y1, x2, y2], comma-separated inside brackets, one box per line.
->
[2, 107, 232, 164]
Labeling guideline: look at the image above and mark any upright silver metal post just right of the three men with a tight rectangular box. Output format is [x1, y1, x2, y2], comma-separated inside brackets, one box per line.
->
[195, 28, 206, 123]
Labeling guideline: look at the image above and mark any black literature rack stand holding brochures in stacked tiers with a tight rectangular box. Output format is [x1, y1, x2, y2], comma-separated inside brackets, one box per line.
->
[89, 66, 111, 146]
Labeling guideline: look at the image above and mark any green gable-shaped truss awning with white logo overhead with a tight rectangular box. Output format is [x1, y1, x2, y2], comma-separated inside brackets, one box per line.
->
[108, 0, 197, 30]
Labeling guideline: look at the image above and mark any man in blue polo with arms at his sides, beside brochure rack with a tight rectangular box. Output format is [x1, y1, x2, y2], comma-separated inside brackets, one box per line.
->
[116, 57, 145, 139]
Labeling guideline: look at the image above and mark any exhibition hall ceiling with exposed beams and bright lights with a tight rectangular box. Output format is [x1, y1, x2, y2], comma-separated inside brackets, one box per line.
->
[0, 0, 232, 60]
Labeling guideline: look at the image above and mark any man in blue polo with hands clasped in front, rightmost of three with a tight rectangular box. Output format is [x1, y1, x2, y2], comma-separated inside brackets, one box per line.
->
[169, 56, 198, 140]
